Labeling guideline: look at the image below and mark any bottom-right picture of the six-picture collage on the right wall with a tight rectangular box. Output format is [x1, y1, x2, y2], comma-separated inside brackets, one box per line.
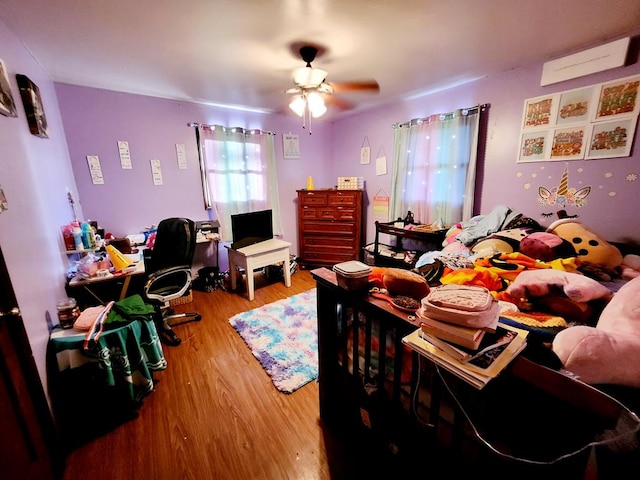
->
[586, 117, 638, 158]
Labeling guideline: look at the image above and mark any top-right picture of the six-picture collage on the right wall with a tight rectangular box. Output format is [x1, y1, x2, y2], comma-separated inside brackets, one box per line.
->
[594, 75, 640, 122]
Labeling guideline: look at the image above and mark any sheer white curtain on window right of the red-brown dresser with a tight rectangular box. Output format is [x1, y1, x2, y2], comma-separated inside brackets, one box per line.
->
[390, 105, 487, 225]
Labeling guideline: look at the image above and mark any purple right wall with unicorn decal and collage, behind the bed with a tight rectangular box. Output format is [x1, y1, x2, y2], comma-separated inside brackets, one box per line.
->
[331, 38, 640, 242]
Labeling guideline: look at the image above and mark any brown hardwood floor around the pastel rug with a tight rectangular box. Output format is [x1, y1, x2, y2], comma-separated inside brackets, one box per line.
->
[64, 270, 388, 480]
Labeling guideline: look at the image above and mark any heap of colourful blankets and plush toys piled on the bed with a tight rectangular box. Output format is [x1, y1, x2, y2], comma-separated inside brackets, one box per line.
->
[408, 206, 640, 386]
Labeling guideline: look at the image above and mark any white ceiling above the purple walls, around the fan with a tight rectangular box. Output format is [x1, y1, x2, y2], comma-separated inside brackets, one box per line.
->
[0, 0, 640, 118]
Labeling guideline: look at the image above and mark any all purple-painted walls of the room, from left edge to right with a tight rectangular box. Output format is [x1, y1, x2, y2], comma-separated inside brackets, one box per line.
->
[0, 12, 640, 402]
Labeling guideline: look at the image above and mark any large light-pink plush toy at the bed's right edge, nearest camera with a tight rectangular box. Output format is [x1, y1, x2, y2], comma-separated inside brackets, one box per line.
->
[553, 277, 640, 387]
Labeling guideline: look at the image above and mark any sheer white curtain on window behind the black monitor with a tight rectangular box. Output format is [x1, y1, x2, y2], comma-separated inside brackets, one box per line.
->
[196, 125, 282, 241]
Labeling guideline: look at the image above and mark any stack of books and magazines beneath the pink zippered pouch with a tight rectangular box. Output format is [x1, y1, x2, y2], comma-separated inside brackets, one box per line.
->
[402, 308, 528, 389]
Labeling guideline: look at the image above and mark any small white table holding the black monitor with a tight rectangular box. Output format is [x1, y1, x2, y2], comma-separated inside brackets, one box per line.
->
[225, 238, 291, 301]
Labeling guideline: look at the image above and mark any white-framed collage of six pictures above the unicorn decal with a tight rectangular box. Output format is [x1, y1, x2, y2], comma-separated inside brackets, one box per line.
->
[518, 75, 640, 163]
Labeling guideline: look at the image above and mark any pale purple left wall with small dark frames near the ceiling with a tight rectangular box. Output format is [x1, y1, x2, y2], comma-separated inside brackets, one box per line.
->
[0, 21, 81, 388]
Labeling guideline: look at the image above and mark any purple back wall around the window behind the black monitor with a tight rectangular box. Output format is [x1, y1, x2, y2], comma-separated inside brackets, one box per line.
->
[56, 84, 336, 269]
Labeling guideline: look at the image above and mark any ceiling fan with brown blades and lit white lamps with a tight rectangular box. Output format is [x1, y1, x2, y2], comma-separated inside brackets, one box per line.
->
[286, 44, 380, 133]
